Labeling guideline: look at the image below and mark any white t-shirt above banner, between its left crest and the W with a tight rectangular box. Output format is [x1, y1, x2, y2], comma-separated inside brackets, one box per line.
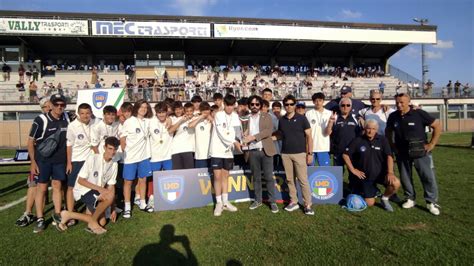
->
[171, 116, 195, 154]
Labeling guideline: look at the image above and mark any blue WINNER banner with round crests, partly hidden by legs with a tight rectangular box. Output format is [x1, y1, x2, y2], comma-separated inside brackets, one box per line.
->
[153, 166, 342, 211]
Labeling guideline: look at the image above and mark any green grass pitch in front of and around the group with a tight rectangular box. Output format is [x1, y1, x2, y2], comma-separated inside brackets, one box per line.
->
[0, 133, 474, 265]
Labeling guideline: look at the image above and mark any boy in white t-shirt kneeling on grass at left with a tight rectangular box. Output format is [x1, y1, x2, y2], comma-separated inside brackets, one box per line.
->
[56, 137, 120, 235]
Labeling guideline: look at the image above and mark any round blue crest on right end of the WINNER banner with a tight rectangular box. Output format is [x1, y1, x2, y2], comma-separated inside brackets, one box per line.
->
[309, 171, 339, 200]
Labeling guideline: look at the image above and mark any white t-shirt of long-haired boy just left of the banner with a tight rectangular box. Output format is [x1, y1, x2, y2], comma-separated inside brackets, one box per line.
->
[120, 116, 150, 164]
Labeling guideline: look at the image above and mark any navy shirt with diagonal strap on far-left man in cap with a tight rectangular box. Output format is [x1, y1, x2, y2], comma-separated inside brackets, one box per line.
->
[29, 112, 69, 163]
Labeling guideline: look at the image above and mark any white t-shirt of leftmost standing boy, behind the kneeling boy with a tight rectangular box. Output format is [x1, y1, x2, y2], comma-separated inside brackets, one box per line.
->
[66, 119, 96, 162]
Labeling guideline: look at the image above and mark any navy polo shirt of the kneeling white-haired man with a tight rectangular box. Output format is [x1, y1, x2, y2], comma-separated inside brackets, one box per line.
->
[344, 134, 392, 181]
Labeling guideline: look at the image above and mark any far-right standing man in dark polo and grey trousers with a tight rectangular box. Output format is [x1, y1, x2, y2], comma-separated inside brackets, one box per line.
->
[385, 93, 441, 215]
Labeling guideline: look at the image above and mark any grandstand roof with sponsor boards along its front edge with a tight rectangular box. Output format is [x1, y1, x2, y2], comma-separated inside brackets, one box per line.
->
[0, 10, 437, 61]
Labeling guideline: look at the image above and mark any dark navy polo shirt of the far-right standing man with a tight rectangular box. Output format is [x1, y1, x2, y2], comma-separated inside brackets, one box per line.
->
[386, 108, 436, 155]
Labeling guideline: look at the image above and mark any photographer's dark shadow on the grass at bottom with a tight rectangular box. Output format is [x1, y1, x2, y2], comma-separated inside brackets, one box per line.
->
[133, 224, 198, 265]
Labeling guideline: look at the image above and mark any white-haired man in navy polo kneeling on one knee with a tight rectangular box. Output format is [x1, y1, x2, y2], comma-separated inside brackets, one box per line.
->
[342, 119, 400, 212]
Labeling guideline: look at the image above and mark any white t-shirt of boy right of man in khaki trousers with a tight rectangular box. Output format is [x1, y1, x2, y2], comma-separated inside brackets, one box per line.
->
[306, 109, 332, 152]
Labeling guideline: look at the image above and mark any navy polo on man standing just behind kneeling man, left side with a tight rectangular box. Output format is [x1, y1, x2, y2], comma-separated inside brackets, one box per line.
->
[331, 114, 362, 154]
